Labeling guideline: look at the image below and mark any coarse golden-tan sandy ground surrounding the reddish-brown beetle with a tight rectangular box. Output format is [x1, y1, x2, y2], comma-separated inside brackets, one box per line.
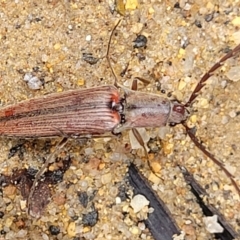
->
[0, 0, 240, 240]
